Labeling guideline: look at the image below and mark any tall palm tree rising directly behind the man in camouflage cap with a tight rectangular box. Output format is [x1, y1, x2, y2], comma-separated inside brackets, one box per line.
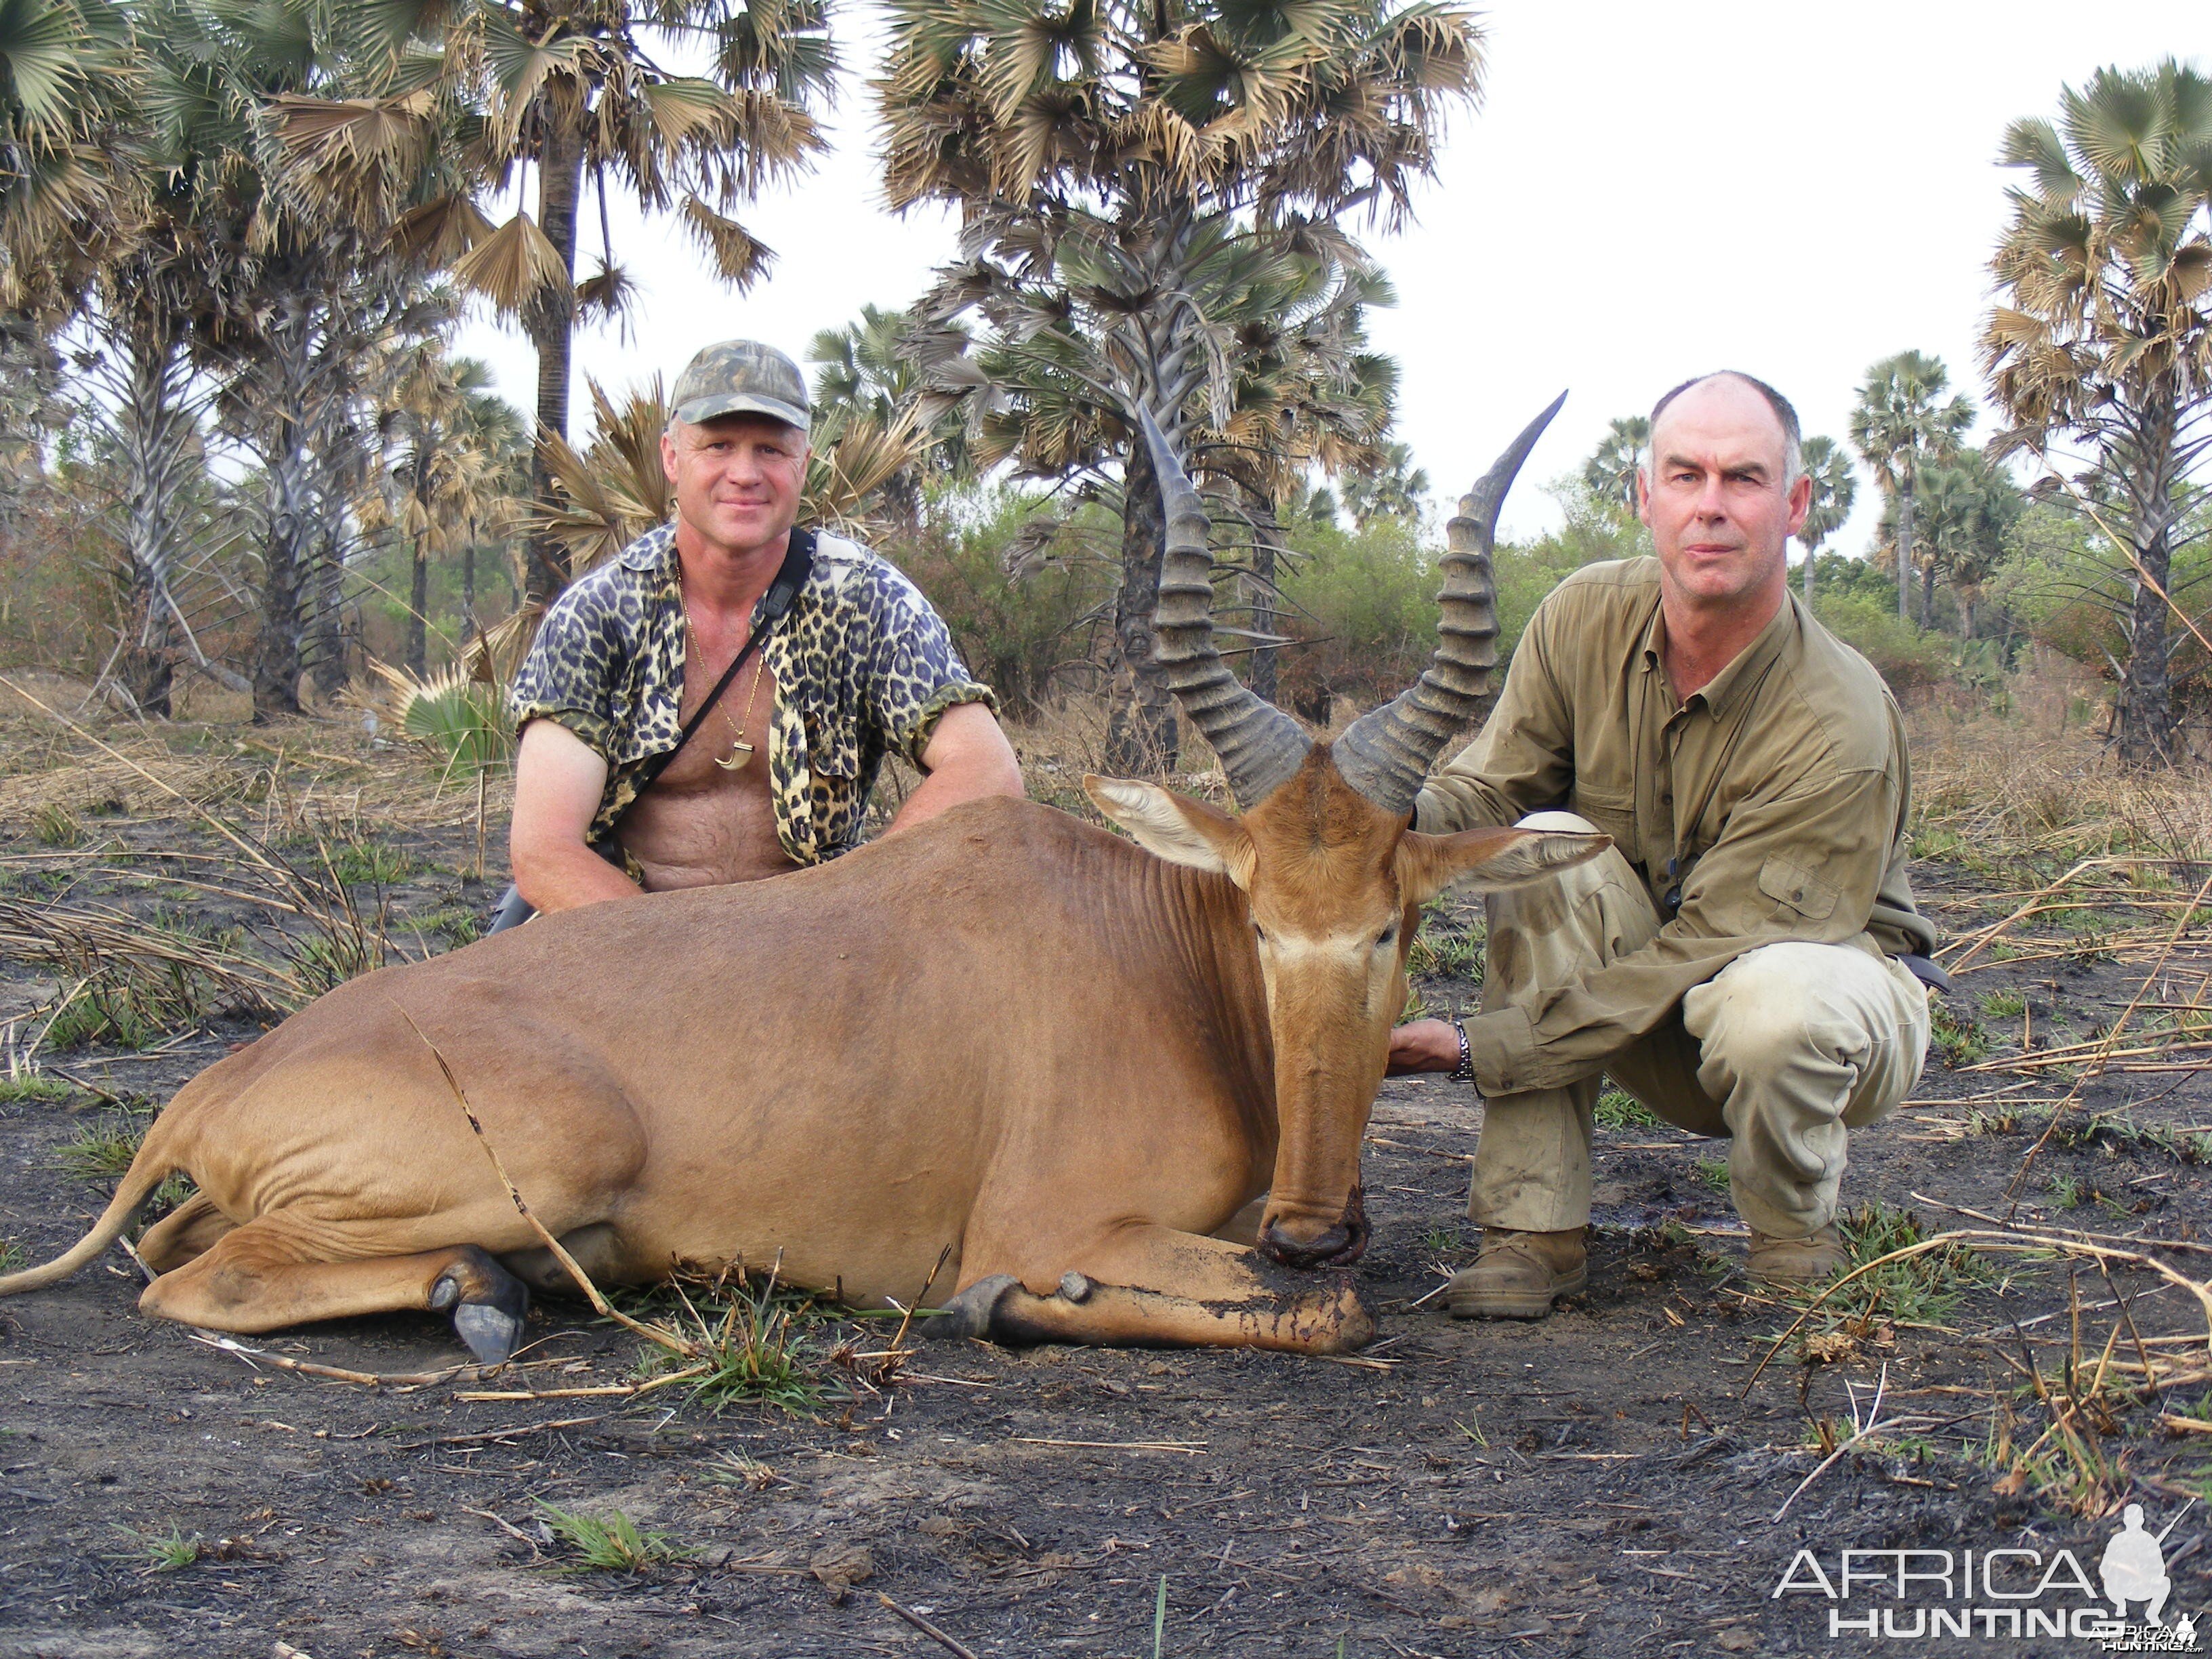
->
[276, 0, 834, 600]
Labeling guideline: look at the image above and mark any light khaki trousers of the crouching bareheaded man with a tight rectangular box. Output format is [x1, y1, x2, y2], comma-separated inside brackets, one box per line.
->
[1467, 812, 1929, 1239]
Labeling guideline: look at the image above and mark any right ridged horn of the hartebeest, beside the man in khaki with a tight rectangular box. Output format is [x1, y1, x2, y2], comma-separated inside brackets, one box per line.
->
[1330, 392, 1566, 827]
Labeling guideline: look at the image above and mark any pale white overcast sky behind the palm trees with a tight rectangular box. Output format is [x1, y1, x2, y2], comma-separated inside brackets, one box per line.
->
[460, 0, 2212, 553]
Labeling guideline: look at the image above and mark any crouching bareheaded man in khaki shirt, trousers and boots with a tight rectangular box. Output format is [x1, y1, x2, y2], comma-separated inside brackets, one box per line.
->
[1391, 374, 1936, 1318]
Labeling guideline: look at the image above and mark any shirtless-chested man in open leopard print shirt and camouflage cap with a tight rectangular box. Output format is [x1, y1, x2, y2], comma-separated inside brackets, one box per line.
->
[509, 341, 1022, 912]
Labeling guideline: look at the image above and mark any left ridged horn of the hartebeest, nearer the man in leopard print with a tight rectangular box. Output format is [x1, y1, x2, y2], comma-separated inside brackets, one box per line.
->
[1137, 409, 1314, 807]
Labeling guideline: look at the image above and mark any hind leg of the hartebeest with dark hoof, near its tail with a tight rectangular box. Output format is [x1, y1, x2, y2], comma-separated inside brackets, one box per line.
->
[140, 1214, 529, 1365]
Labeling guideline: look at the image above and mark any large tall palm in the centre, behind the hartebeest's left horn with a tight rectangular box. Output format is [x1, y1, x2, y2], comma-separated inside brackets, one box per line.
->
[878, 0, 1482, 763]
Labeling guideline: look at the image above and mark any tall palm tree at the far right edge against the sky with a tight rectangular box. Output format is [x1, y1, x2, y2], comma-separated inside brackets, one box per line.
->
[1982, 58, 2212, 765]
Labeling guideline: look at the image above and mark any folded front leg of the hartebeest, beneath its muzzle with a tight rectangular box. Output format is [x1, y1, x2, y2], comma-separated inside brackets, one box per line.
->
[931, 1225, 1376, 1354]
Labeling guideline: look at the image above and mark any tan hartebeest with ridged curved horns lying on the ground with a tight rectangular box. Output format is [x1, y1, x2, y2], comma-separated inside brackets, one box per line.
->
[0, 405, 1606, 1363]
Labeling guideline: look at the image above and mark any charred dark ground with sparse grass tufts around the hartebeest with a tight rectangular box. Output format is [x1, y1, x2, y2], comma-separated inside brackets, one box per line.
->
[0, 721, 2212, 1659]
